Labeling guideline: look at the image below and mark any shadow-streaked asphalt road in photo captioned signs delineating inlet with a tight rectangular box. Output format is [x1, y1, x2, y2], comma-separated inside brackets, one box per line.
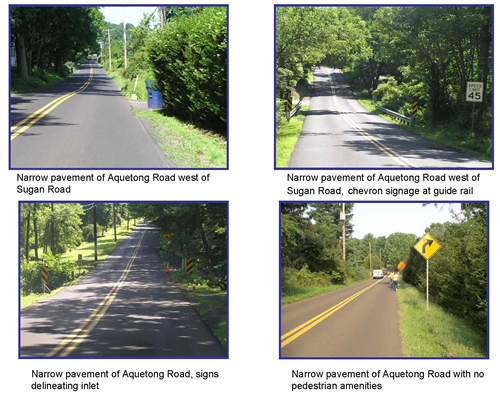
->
[20, 223, 227, 358]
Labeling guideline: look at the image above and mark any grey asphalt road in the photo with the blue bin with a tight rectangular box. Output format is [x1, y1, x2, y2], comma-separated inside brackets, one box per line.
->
[10, 59, 173, 169]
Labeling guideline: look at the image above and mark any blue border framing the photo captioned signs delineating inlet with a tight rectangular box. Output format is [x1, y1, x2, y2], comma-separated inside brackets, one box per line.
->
[17, 200, 229, 360]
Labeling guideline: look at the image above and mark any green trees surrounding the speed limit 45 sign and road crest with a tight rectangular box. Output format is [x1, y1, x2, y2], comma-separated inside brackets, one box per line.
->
[276, 6, 493, 156]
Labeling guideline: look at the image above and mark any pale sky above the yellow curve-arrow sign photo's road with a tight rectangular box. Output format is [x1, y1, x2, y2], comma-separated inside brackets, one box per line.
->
[352, 203, 460, 239]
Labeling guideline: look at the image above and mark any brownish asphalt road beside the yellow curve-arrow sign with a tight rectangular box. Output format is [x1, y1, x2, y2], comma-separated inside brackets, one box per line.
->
[280, 278, 403, 358]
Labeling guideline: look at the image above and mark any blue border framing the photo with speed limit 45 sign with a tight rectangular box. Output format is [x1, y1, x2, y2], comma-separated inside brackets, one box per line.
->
[273, 4, 495, 171]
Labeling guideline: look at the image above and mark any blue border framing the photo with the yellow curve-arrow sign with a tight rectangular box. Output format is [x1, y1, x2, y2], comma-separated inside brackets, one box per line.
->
[278, 200, 490, 360]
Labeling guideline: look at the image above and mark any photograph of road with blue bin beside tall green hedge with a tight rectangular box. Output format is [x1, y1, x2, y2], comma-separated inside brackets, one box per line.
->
[9, 5, 228, 169]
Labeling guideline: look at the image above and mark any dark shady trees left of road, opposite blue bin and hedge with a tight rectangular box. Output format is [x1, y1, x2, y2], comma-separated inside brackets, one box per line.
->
[11, 7, 104, 79]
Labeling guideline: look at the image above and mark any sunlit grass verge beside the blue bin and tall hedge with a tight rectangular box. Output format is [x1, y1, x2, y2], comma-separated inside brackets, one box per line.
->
[107, 70, 227, 168]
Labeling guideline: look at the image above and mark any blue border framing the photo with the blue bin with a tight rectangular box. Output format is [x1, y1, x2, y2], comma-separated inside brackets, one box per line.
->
[7, 3, 229, 171]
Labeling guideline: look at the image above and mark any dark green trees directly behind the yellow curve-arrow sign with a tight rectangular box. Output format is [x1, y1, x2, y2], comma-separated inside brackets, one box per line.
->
[404, 203, 488, 331]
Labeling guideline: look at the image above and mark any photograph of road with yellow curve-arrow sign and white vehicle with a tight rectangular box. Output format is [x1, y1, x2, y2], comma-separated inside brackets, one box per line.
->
[280, 202, 489, 359]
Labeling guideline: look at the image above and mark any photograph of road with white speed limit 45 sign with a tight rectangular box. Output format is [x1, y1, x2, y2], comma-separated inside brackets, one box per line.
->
[274, 5, 493, 169]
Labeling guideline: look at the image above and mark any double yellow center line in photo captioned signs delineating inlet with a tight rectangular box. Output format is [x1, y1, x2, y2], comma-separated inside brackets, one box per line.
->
[46, 231, 146, 357]
